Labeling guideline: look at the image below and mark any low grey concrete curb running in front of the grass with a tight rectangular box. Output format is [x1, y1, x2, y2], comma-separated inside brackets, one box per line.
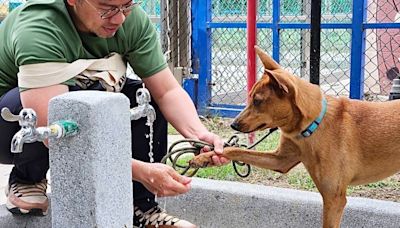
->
[0, 178, 400, 228]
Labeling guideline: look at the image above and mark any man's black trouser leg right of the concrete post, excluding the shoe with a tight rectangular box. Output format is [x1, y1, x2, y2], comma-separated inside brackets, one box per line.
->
[121, 79, 168, 211]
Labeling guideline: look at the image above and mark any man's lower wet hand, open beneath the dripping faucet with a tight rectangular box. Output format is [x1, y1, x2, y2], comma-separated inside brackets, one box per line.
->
[132, 160, 192, 197]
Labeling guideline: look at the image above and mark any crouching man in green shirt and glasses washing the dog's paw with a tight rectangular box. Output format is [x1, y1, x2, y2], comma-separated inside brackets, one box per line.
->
[0, 0, 227, 227]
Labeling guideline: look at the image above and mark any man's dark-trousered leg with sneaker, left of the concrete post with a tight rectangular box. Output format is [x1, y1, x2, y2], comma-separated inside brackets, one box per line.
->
[0, 88, 49, 215]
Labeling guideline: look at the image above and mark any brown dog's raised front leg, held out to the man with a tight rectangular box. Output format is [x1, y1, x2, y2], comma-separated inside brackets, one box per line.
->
[189, 147, 300, 173]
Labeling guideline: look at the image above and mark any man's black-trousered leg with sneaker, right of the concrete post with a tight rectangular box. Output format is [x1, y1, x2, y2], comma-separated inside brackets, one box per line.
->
[122, 79, 196, 227]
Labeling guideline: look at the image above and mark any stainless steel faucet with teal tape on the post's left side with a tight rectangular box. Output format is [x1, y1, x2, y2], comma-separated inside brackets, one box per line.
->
[1, 108, 78, 153]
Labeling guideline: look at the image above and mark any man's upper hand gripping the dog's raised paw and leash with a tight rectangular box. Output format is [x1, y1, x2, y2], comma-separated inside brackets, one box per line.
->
[199, 131, 229, 166]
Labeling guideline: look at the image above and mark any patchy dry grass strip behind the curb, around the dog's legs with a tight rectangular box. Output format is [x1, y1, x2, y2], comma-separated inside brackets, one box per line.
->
[168, 117, 400, 202]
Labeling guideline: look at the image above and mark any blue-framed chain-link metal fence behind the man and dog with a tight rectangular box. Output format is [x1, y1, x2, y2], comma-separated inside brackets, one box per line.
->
[0, 0, 400, 116]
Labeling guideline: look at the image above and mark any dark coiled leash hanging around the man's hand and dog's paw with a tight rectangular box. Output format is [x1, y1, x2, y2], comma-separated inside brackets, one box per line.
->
[161, 128, 278, 178]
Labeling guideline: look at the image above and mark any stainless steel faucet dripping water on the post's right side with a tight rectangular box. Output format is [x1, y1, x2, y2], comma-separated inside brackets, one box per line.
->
[130, 88, 156, 124]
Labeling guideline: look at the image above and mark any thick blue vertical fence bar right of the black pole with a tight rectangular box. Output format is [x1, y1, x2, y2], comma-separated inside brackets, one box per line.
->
[350, 0, 367, 99]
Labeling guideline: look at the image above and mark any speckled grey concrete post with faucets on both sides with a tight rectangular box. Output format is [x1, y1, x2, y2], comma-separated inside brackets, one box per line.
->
[49, 91, 133, 228]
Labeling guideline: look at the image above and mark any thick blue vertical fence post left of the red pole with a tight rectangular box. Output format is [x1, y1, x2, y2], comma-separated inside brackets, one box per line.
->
[192, 0, 212, 115]
